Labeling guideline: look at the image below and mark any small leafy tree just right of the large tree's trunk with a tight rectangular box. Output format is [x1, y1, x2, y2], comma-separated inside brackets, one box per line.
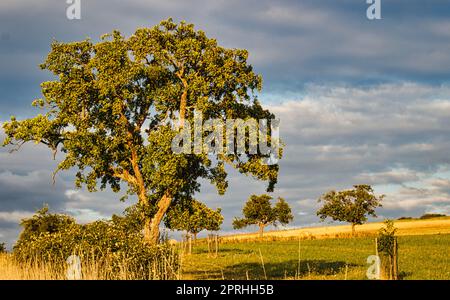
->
[165, 200, 223, 240]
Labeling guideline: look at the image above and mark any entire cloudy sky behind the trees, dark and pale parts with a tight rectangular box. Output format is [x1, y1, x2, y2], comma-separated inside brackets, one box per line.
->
[0, 0, 450, 245]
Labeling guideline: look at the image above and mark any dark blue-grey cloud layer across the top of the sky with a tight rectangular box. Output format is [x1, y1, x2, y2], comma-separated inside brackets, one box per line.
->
[0, 0, 450, 119]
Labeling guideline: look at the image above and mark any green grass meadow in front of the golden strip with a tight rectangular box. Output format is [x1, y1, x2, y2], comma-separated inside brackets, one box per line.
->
[183, 234, 450, 280]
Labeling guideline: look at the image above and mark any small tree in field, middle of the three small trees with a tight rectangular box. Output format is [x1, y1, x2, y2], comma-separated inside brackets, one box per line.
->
[233, 194, 294, 237]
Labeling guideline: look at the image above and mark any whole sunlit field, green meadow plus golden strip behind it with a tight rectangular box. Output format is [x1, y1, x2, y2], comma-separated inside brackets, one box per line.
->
[183, 218, 450, 280]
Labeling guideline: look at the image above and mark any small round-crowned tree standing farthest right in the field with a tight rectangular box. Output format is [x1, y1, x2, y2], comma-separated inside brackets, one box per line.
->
[317, 185, 384, 235]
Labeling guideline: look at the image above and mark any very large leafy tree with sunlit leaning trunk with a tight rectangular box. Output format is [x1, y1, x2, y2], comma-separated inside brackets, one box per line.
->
[3, 19, 278, 242]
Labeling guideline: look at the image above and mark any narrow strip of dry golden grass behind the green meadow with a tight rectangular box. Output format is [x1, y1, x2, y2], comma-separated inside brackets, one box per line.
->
[217, 218, 450, 242]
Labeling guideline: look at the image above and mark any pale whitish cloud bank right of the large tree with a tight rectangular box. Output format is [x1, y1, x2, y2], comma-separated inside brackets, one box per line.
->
[260, 82, 450, 214]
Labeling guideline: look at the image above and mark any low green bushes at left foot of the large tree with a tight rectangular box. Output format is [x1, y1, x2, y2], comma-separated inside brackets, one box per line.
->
[13, 208, 179, 279]
